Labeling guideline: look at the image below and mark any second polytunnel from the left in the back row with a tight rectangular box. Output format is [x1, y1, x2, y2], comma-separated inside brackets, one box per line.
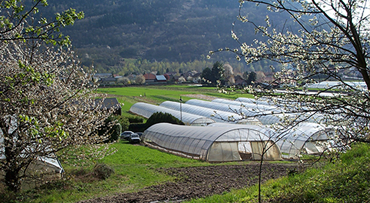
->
[160, 101, 251, 123]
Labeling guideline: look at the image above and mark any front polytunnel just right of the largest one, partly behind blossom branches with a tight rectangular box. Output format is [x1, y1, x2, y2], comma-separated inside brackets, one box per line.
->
[275, 123, 336, 158]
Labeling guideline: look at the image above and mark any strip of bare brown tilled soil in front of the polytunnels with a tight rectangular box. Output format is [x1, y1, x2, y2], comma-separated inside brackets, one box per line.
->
[82, 163, 296, 203]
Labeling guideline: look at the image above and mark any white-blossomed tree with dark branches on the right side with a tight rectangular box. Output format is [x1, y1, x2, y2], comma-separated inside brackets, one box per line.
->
[211, 0, 370, 201]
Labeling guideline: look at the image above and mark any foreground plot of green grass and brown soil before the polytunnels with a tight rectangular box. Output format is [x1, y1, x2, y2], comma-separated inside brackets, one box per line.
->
[18, 141, 295, 202]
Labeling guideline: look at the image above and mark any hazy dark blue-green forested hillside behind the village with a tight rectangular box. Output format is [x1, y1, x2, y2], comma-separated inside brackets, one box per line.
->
[42, 0, 300, 73]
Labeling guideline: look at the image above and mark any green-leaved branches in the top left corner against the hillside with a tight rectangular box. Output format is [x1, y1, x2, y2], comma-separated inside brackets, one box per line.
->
[0, 0, 84, 46]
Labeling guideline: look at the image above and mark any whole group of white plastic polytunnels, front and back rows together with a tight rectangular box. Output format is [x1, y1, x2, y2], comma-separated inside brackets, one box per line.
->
[130, 98, 342, 162]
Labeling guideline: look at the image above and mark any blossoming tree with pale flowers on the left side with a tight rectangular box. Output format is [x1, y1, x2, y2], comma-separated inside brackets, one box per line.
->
[0, 0, 110, 192]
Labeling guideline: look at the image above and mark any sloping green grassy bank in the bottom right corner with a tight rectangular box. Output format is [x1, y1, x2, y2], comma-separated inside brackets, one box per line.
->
[188, 144, 370, 203]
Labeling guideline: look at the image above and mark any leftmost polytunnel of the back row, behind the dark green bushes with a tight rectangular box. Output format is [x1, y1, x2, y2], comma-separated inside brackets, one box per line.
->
[130, 102, 215, 125]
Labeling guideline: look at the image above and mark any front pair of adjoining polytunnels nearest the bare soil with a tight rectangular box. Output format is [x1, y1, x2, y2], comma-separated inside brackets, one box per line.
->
[144, 123, 335, 162]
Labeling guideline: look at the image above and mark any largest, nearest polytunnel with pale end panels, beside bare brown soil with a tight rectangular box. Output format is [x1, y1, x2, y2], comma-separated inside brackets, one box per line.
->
[144, 123, 281, 162]
